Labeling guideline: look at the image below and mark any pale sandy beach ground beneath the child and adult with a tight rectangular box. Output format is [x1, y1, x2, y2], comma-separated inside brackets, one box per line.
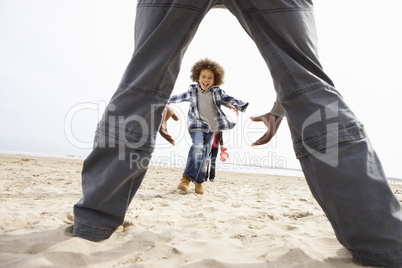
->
[0, 155, 402, 267]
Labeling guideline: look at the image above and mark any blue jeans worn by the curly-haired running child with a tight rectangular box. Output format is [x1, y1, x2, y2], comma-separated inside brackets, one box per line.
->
[183, 131, 215, 184]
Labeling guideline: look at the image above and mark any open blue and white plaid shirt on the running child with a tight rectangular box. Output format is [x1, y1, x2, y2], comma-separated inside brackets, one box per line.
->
[168, 84, 248, 132]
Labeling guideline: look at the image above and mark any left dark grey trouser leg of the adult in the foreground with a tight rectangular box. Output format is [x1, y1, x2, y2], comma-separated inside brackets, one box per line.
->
[73, 0, 213, 241]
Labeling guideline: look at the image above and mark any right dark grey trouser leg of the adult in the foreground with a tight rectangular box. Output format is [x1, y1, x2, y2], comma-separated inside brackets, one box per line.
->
[223, 0, 402, 267]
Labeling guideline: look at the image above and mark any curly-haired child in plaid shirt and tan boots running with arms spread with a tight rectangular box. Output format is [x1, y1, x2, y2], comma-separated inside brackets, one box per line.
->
[164, 59, 248, 194]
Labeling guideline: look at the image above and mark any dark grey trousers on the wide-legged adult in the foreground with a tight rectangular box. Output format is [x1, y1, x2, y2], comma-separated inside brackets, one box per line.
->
[73, 0, 402, 267]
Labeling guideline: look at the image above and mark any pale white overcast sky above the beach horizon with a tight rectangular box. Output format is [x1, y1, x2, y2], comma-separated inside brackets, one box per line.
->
[0, 0, 402, 178]
